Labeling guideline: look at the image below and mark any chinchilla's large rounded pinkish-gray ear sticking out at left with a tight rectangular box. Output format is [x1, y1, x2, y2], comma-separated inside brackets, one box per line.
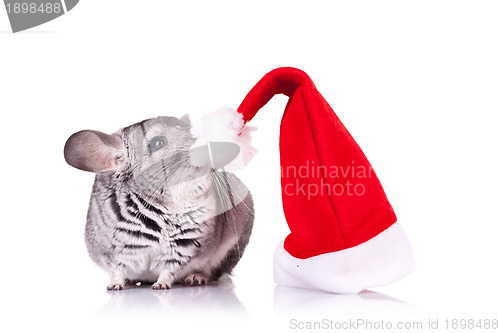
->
[64, 130, 126, 172]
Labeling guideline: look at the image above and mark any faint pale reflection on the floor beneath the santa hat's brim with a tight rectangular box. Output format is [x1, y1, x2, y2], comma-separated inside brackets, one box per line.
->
[274, 286, 417, 316]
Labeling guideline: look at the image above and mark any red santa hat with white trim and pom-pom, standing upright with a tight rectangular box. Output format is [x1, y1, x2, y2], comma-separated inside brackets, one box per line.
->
[193, 67, 415, 293]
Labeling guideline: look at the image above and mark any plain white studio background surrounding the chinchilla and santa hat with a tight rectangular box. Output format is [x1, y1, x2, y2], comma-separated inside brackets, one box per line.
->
[0, 0, 500, 332]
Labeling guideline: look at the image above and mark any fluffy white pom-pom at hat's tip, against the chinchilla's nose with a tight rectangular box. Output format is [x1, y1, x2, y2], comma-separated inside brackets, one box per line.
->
[191, 108, 257, 171]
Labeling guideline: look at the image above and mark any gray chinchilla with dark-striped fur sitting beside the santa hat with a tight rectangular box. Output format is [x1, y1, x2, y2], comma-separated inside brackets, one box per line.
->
[65, 117, 254, 290]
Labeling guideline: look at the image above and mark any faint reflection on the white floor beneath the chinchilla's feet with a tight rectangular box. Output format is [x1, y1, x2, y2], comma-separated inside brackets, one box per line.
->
[99, 279, 246, 317]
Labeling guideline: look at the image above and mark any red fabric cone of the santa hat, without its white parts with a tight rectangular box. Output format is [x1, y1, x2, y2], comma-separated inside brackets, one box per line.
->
[238, 68, 396, 259]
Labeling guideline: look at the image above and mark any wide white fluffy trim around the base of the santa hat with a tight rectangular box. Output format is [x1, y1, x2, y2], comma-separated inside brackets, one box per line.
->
[274, 222, 415, 294]
